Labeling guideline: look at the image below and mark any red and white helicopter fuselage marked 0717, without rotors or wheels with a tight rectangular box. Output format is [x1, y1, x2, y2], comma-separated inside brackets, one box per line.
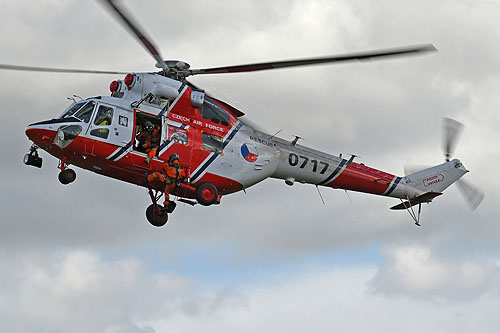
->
[26, 74, 466, 204]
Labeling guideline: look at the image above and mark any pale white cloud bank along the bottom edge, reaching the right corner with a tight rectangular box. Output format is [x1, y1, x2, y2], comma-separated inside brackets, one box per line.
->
[154, 266, 499, 333]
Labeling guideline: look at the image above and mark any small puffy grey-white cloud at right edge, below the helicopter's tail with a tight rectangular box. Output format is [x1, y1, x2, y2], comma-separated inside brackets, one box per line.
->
[371, 245, 500, 301]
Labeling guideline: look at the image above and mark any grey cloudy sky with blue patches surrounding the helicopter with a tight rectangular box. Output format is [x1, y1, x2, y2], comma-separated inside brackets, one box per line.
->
[0, 0, 500, 332]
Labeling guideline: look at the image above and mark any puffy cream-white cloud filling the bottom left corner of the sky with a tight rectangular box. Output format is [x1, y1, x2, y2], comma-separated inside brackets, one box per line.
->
[0, 250, 245, 332]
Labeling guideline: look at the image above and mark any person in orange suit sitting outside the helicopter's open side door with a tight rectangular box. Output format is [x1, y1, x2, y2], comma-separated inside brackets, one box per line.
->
[145, 154, 188, 213]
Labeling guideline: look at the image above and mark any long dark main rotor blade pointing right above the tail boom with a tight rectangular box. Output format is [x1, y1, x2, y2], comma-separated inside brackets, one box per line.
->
[191, 44, 437, 75]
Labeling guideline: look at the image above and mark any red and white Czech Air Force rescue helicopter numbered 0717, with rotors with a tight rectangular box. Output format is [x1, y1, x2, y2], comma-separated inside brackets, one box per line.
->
[8, 0, 483, 226]
